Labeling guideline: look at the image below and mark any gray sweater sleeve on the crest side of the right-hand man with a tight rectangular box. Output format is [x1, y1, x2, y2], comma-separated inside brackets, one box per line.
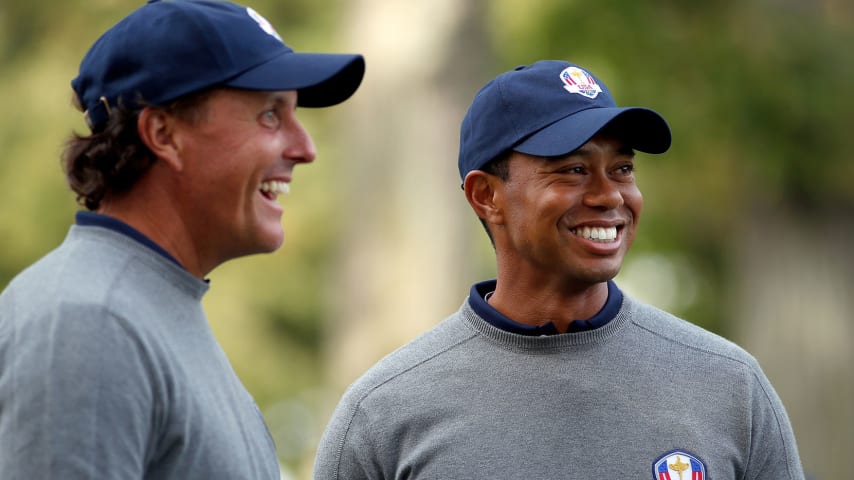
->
[744, 364, 804, 480]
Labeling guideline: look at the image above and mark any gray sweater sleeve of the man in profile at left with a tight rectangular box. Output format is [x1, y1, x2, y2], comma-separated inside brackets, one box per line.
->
[0, 305, 154, 480]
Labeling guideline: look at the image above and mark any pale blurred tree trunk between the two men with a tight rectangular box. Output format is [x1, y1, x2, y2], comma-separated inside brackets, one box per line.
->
[328, 0, 491, 388]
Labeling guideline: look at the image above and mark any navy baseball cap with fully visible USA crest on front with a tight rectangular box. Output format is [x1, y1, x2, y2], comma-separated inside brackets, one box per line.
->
[458, 60, 670, 179]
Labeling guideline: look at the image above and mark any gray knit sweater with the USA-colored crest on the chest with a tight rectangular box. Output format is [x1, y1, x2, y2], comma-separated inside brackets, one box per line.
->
[314, 296, 804, 480]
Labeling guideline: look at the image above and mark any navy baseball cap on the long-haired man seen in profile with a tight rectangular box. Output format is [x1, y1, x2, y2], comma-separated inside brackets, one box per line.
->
[71, 0, 365, 131]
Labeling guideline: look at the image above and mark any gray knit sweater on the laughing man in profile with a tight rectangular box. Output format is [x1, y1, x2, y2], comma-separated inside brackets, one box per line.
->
[0, 226, 279, 480]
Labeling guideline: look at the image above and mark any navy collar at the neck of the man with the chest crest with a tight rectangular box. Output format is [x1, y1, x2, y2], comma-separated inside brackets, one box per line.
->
[469, 280, 623, 336]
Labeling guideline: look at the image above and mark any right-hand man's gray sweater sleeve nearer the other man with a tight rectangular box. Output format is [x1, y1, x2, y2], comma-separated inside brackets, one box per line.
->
[314, 394, 382, 480]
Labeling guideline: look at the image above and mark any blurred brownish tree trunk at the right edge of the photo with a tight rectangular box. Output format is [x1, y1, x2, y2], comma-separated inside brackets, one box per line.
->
[733, 209, 854, 479]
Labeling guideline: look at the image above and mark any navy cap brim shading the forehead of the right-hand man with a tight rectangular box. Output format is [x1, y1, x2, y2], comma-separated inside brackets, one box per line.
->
[513, 107, 670, 157]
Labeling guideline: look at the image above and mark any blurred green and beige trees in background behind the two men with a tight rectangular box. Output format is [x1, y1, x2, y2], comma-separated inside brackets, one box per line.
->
[0, 0, 854, 479]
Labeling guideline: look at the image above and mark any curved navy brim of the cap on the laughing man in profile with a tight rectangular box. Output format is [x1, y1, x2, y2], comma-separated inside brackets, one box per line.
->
[224, 52, 365, 107]
